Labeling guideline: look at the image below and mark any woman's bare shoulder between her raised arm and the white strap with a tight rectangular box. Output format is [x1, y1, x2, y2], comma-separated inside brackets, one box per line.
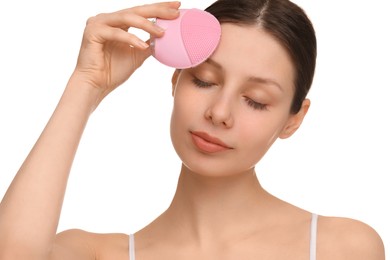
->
[52, 229, 129, 260]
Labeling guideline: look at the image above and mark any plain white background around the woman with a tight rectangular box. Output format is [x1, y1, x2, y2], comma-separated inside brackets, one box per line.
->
[0, 0, 390, 253]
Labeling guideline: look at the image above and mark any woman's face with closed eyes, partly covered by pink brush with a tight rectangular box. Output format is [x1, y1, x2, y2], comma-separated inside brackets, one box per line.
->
[171, 23, 304, 176]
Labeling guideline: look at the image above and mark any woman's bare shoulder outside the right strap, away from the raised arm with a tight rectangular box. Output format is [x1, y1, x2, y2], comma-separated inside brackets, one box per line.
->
[317, 217, 385, 260]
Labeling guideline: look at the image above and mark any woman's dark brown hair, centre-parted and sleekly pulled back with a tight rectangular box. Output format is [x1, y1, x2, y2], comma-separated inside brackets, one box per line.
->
[206, 0, 317, 114]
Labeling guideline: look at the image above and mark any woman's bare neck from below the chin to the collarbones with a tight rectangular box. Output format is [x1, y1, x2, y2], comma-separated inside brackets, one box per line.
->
[161, 166, 274, 243]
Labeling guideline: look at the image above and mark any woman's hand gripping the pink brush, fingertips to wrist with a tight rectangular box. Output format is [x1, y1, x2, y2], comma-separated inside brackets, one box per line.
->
[73, 2, 180, 102]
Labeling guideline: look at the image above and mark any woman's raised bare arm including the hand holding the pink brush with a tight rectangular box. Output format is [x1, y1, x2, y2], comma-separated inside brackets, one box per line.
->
[0, 2, 180, 260]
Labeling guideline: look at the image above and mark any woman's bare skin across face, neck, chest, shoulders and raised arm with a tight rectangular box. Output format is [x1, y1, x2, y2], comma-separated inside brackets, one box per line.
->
[0, 2, 385, 260]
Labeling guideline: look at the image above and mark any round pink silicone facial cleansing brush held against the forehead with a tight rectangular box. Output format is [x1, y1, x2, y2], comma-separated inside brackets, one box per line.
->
[151, 8, 221, 69]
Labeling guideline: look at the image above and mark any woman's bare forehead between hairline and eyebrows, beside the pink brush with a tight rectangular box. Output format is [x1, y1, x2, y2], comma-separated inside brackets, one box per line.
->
[211, 23, 294, 91]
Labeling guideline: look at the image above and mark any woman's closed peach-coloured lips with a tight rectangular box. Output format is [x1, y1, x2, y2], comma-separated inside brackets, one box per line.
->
[191, 132, 232, 153]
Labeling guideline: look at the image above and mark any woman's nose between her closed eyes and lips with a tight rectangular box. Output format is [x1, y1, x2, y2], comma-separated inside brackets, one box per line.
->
[205, 97, 234, 128]
